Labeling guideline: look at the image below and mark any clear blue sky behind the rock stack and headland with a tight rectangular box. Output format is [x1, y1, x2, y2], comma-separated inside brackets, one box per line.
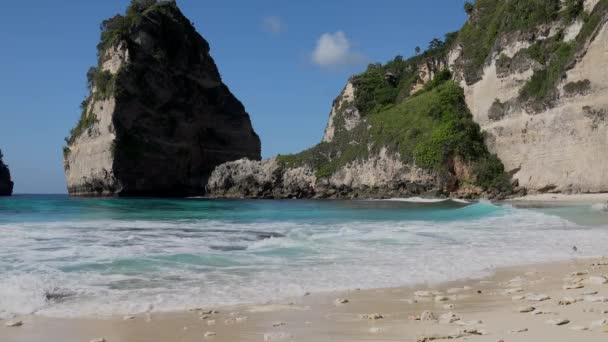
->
[0, 0, 465, 193]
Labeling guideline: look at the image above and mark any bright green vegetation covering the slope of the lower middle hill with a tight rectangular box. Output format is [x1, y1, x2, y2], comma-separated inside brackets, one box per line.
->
[278, 61, 510, 190]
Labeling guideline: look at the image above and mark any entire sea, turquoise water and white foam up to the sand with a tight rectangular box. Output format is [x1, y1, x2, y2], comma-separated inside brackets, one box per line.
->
[0, 195, 608, 318]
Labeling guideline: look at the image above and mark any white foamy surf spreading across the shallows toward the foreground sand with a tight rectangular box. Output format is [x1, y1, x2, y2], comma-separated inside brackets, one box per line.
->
[0, 203, 608, 318]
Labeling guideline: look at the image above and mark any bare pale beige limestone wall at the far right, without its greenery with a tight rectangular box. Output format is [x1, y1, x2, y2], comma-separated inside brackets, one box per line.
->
[451, 18, 608, 192]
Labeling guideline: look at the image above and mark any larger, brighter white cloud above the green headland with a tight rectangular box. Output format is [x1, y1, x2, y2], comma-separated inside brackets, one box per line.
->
[312, 31, 365, 67]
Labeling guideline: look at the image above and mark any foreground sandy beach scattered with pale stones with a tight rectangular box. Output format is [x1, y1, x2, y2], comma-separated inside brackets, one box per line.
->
[0, 258, 608, 342]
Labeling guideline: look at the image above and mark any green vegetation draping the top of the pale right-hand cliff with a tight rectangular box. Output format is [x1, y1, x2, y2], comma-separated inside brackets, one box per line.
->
[458, 0, 608, 109]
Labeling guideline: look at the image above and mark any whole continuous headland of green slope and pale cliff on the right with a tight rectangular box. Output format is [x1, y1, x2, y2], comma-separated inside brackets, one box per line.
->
[208, 0, 608, 198]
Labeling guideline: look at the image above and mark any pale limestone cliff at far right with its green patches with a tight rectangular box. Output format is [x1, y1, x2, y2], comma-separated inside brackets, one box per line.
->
[450, 0, 608, 193]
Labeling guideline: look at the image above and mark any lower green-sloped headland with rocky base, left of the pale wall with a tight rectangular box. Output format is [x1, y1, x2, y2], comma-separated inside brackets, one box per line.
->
[207, 60, 508, 198]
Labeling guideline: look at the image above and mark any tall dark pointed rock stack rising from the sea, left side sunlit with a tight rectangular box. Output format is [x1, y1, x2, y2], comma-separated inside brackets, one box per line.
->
[64, 0, 260, 196]
